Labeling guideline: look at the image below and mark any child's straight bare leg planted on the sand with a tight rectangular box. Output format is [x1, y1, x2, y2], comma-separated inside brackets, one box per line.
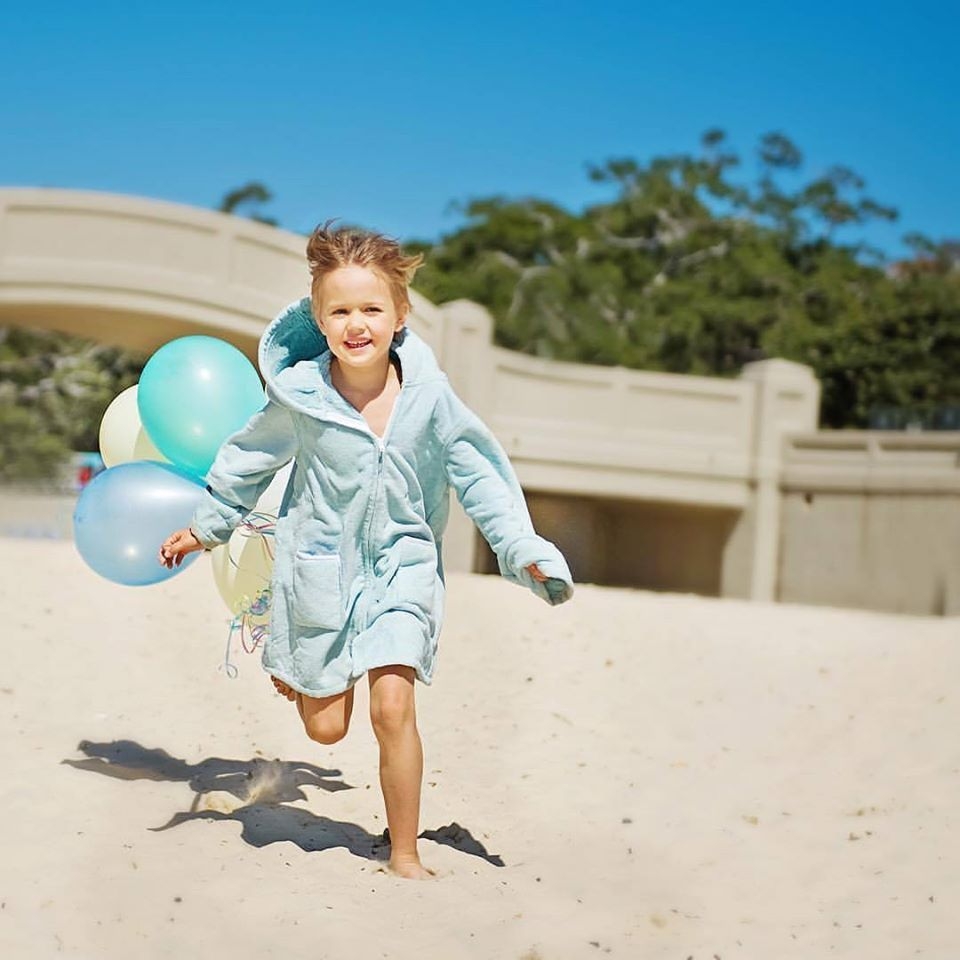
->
[369, 665, 431, 879]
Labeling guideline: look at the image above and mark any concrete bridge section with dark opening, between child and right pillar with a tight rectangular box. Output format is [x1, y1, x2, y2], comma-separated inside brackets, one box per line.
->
[440, 301, 819, 599]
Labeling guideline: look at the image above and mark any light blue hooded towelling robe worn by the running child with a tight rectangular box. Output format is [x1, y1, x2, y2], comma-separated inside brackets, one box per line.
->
[191, 298, 573, 697]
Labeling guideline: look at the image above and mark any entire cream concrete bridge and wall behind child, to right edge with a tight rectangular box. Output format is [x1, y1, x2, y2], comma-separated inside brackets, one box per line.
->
[0, 189, 960, 613]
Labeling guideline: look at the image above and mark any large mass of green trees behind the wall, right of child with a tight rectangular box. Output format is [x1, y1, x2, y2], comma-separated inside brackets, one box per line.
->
[416, 130, 960, 426]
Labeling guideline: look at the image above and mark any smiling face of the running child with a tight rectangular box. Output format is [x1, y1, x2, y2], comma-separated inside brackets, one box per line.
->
[317, 264, 406, 370]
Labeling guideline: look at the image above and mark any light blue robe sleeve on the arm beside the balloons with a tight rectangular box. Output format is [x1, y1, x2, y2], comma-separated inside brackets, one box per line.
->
[190, 400, 299, 549]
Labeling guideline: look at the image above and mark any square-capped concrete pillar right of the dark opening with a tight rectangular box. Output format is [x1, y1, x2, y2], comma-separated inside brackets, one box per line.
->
[721, 360, 820, 600]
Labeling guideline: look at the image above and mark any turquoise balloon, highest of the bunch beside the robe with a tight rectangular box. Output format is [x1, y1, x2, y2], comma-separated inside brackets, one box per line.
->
[137, 336, 266, 477]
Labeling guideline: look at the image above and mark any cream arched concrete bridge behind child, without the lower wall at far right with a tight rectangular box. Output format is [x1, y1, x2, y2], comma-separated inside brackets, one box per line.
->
[0, 190, 818, 597]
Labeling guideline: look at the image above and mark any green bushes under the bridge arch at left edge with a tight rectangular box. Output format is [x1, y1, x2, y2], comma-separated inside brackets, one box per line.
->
[0, 327, 145, 480]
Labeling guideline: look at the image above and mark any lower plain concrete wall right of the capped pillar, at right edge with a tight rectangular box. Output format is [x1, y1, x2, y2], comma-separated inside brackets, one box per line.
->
[778, 431, 960, 615]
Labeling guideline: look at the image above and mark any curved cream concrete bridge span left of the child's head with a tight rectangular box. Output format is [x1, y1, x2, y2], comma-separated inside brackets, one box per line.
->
[0, 189, 448, 358]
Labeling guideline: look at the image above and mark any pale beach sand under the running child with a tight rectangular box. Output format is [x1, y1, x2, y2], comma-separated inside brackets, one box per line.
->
[0, 539, 960, 960]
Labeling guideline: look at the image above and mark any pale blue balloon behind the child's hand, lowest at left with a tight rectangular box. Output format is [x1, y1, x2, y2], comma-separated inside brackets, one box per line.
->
[73, 460, 204, 587]
